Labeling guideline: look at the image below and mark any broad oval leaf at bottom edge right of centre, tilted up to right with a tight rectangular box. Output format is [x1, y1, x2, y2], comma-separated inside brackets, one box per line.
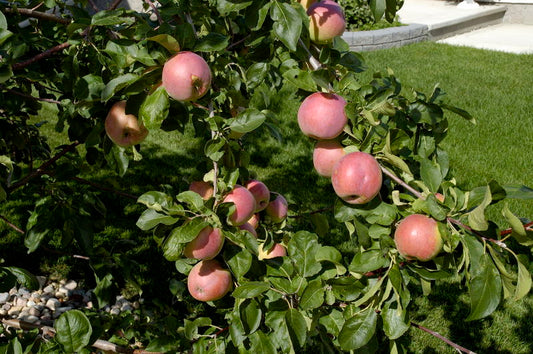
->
[339, 307, 378, 350]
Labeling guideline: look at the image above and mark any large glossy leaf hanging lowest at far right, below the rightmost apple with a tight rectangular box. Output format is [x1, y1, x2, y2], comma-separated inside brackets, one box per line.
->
[466, 254, 502, 321]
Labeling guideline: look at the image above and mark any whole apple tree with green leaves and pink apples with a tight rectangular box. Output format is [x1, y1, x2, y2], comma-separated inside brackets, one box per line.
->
[0, 0, 533, 353]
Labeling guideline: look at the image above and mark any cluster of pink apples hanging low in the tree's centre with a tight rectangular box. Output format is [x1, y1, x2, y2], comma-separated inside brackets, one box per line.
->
[183, 180, 288, 301]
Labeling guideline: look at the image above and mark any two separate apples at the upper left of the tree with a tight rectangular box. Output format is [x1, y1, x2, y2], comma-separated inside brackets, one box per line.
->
[105, 51, 211, 148]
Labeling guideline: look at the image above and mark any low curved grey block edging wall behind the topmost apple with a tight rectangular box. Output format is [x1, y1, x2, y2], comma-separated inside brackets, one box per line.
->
[342, 24, 429, 52]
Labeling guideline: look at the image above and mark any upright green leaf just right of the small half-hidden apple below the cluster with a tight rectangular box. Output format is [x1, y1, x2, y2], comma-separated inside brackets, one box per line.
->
[288, 231, 322, 277]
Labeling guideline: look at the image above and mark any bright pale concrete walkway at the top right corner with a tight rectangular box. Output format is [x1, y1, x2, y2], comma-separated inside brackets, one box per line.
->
[398, 0, 533, 54]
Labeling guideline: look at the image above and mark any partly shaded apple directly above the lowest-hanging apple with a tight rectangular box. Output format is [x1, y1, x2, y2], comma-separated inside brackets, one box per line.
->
[183, 226, 224, 259]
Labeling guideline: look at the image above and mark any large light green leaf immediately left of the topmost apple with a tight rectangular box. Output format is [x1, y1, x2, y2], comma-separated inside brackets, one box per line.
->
[270, 1, 302, 52]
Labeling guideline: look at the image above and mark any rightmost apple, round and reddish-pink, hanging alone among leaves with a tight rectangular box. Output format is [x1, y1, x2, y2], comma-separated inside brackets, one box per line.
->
[394, 214, 442, 262]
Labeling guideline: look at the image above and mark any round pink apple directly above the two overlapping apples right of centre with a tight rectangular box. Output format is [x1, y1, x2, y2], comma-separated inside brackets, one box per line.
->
[298, 92, 348, 140]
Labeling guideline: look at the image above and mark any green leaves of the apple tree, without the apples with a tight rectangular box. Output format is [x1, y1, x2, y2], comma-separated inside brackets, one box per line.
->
[0, 0, 533, 353]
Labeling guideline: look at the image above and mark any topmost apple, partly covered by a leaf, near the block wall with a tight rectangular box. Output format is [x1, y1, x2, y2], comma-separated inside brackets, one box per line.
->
[307, 0, 346, 44]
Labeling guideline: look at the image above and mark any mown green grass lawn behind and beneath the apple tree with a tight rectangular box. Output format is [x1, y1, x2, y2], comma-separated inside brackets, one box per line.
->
[4, 43, 533, 353]
